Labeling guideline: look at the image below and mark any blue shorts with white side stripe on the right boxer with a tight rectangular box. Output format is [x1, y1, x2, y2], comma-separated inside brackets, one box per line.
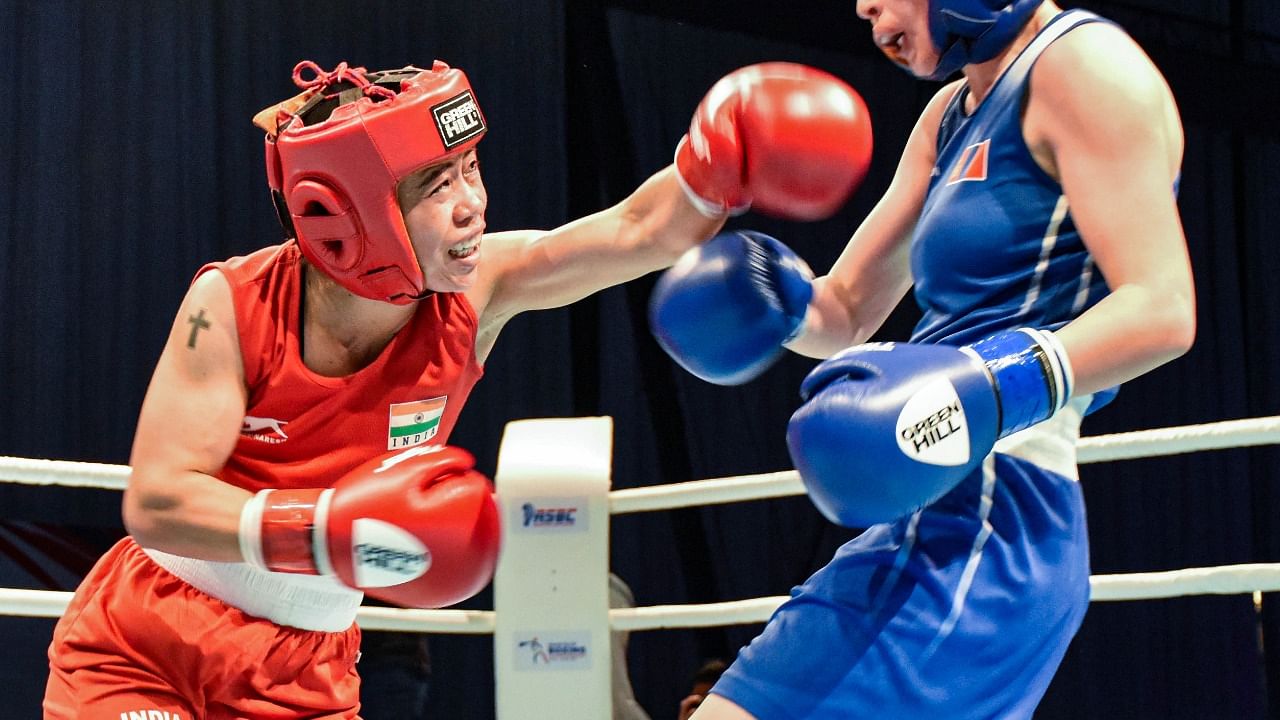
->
[712, 454, 1089, 720]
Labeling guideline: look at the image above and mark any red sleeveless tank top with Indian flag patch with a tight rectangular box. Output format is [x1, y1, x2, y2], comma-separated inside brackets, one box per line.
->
[197, 241, 484, 491]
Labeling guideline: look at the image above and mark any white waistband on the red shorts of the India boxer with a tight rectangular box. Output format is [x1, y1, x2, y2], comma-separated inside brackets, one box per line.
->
[142, 548, 365, 633]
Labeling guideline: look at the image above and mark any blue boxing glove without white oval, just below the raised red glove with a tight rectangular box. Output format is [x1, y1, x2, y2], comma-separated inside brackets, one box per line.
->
[649, 231, 813, 384]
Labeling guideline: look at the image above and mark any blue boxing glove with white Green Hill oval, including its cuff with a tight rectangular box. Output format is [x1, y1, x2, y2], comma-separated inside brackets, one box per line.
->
[787, 328, 1071, 528]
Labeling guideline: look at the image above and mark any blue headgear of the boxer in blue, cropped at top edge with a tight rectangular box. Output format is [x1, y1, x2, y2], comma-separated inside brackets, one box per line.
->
[929, 0, 1044, 79]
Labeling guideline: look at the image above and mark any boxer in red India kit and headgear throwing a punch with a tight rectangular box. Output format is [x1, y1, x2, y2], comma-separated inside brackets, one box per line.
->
[44, 63, 870, 720]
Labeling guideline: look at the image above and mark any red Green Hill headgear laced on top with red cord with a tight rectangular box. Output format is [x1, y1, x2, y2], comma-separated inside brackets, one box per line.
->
[255, 60, 486, 304]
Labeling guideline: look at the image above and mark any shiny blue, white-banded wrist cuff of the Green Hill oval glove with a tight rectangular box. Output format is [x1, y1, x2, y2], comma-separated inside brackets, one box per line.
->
[970, 328, 1074, 437]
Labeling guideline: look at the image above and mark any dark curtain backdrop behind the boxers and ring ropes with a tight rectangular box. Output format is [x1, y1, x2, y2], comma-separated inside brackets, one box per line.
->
[0, 0, 1280, 720]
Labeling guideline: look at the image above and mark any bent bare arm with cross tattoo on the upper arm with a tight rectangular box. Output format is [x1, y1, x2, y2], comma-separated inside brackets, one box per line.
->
[123, 272, 250, 562]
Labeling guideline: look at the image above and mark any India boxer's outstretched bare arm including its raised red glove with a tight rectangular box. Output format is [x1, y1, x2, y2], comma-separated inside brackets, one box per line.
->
[467, 63, 872, 359]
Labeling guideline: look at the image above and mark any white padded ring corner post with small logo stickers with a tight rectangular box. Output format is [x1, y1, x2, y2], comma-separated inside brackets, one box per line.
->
[493, 418, 613, 720]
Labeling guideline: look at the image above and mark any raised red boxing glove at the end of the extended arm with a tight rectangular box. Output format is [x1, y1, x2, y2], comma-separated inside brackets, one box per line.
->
[676, 63, 872, 220]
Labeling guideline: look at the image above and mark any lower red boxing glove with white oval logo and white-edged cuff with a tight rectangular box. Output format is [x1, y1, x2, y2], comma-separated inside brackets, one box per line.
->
[241, 446, 499, 607]
